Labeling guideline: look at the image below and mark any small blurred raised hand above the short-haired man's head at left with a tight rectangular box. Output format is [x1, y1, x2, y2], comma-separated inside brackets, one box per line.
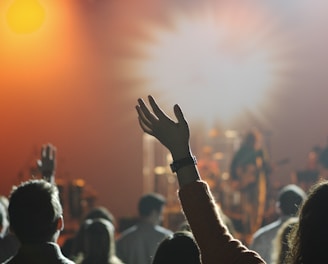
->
[37, 144, 57, 183]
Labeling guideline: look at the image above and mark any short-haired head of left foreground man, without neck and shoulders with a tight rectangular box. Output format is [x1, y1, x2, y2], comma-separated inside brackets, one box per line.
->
[8, 180, 64, 244]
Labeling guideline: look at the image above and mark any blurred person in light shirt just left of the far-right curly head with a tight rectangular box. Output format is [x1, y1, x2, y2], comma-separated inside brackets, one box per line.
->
[250, 184, 306, 264]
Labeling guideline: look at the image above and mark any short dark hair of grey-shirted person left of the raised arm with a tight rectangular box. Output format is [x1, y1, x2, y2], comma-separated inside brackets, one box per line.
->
[138, 193, 166, 216]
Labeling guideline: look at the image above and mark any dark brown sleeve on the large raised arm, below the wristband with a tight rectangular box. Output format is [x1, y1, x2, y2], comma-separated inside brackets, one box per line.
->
[179, 181, 265, 264]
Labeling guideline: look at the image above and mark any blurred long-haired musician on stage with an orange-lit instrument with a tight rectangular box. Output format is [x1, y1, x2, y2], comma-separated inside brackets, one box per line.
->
[230, 129, 271, 240]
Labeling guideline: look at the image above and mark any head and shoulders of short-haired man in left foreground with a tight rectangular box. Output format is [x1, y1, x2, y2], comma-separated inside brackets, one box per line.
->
[5, 180, 73, 264]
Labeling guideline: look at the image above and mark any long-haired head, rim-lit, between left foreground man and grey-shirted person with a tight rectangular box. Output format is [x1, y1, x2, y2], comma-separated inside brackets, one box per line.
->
[82, 218, 122, 264]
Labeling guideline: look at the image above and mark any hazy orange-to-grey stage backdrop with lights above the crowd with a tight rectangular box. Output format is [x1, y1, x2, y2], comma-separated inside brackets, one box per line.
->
[0, 0, 328, 231]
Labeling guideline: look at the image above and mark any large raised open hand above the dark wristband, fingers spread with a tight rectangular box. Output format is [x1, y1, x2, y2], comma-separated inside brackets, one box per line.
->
[136, 96, 190, 160]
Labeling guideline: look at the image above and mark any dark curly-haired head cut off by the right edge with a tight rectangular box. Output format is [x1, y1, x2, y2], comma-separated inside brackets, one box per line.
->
[288, 181, 328, 264]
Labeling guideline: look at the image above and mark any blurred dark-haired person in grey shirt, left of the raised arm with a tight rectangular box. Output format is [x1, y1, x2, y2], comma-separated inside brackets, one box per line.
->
[116, 193, 172, 264]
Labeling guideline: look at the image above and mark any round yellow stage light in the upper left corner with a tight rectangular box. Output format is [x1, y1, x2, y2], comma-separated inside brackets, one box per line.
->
[6, 0, 46, 34]
